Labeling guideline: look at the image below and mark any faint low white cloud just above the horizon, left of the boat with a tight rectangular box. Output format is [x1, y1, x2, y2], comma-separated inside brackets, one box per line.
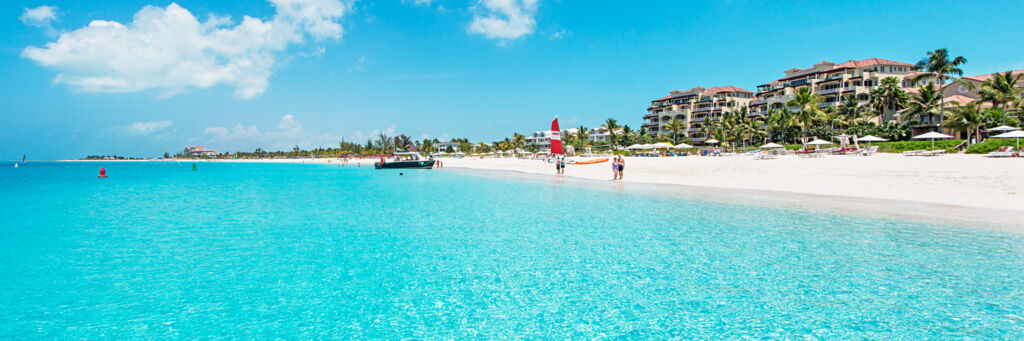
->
[201, 115, 342, 151]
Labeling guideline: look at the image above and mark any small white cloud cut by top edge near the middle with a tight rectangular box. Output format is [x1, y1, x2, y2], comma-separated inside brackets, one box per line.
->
[469, 0, 538, 43]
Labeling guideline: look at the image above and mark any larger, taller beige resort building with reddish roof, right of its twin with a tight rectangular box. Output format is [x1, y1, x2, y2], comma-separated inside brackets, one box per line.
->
[750, 58, 918, 123]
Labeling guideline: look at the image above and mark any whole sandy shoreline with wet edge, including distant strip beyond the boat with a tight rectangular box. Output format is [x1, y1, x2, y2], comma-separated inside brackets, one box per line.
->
[58, 155, 1024, 233]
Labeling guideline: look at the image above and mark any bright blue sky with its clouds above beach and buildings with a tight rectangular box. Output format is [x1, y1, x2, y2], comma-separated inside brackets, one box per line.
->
[0, 0, 1024, 160]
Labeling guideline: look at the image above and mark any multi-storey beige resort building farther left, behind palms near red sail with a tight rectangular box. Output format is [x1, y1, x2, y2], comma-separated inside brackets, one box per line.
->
[642, 86, 757, 142]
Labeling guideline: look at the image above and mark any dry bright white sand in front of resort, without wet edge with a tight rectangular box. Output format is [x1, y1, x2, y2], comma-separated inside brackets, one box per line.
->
[444, 154, 1024, 210]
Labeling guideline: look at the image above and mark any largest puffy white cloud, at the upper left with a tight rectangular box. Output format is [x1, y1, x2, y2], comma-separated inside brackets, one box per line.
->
[22, 0, 348, 99]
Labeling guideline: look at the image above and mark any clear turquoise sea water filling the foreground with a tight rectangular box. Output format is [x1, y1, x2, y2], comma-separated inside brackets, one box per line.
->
[0, 163, 1024, 339]
